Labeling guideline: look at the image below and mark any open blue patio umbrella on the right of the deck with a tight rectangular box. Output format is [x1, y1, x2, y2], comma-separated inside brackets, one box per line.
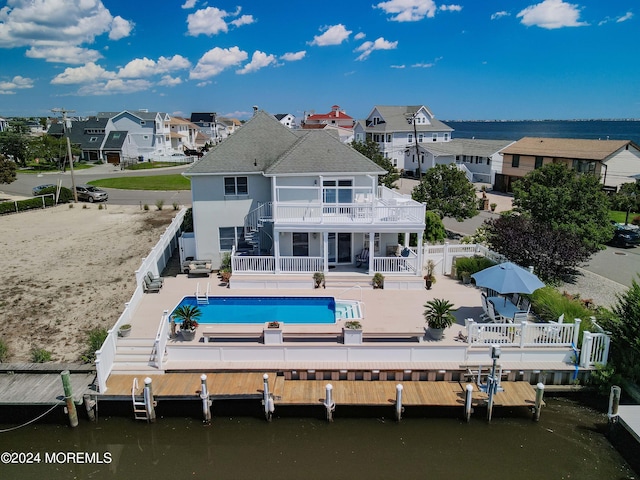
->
[471, 262, 544, 294]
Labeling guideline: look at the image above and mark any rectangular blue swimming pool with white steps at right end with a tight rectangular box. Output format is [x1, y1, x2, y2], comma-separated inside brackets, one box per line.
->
[170, 296, 362, 325]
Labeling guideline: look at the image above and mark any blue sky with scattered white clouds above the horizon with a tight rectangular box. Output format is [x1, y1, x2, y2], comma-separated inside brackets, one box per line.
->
[0, 0, 640, 120]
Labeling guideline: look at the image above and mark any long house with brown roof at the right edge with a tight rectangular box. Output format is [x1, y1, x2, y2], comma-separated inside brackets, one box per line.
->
[495, 137, 640, 192]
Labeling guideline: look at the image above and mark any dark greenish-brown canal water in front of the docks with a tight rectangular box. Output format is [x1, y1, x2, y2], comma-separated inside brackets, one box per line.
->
[0, 398, 638, 480]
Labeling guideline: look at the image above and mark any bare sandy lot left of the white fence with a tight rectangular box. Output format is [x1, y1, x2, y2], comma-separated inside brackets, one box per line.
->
[0, 204, 176, 362]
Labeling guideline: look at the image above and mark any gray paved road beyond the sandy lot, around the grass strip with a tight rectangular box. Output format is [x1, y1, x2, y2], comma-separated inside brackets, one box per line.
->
[0, 165, 191, 206]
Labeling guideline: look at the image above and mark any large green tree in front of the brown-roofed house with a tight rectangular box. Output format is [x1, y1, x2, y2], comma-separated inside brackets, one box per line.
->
[513, 163, 613, 253]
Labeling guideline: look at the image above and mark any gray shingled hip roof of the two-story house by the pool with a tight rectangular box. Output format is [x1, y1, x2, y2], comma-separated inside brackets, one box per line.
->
[185, 111, 385, 176]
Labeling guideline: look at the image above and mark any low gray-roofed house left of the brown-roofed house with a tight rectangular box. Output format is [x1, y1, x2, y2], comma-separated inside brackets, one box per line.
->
[423, 138, 513, 185]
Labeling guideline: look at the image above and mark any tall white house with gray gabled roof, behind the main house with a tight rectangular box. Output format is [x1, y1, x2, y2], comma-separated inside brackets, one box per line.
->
[354, 105, 453, 176]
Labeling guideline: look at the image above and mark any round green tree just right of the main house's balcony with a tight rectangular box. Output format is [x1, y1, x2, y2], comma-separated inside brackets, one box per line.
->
[412, 165, 478, 222]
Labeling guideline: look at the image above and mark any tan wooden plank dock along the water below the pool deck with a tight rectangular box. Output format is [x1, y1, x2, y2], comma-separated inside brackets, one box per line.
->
[102, 372, 535, 407]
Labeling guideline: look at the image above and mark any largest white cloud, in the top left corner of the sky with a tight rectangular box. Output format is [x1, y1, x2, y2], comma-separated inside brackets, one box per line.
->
[0, 0, 133, 64]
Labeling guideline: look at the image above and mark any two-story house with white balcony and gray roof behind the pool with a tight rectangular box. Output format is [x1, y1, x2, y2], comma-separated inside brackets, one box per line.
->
[184, 111, 425, 278]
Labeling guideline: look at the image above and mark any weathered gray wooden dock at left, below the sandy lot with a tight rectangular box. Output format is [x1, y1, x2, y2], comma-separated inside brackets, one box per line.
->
[0, 364, 96, 405]
